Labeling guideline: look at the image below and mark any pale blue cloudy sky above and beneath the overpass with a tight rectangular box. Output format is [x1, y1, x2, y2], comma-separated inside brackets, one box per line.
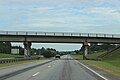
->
[0, 0, 120, 50]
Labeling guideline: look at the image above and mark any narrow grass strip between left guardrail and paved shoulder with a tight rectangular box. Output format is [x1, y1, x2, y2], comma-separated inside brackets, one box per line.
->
[0, 58, 47, 67]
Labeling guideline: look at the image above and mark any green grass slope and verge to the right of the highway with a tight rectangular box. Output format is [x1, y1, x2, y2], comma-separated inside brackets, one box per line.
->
[72, 49, 120, 77]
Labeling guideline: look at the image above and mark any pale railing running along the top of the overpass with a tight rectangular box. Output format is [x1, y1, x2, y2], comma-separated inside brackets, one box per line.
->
[0, 31, 120, 38]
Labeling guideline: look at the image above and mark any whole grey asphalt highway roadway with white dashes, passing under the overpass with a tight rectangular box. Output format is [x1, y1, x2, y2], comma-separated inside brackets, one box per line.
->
[0, 55, 104, 80]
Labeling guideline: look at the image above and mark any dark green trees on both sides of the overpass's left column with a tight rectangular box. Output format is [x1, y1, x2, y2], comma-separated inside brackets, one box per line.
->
[0, 42, 58, 58]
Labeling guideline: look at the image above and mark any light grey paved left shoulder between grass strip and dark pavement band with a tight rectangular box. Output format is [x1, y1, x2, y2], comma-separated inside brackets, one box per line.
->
[0, 60, 51, 76]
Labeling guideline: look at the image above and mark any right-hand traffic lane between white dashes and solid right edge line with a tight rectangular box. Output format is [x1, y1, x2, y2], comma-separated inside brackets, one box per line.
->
[33, 55, 101, 80]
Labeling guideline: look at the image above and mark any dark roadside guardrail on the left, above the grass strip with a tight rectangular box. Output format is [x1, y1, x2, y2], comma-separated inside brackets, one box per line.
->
[0, 57, 40, 64]
